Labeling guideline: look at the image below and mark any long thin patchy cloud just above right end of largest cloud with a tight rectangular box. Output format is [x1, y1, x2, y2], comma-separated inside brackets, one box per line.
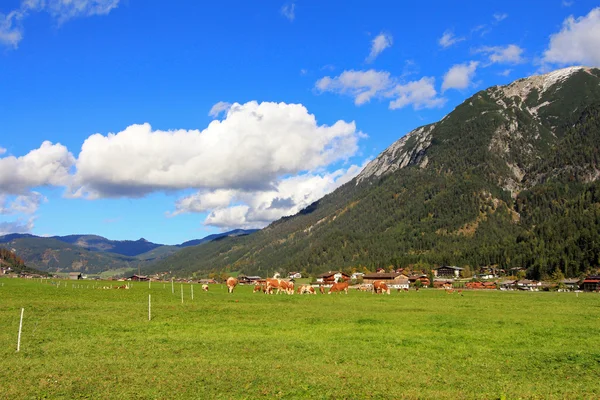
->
[315, 69, 445, 109]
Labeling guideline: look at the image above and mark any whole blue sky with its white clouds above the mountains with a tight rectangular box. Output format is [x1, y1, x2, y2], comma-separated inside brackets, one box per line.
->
[0, 0, 600, 244]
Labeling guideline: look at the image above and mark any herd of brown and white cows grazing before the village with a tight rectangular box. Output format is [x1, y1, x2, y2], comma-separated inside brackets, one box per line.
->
[223, 277, 390, 294]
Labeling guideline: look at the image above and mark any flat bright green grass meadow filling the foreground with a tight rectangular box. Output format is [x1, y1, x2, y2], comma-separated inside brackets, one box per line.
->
[0, 279, 600, 399]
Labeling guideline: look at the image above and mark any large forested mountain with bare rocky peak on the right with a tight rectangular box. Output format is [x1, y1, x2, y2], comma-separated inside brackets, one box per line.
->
[150, 67, 600, 278]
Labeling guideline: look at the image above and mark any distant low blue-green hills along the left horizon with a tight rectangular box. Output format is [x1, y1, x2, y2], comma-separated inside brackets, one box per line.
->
[0, 229, 253, 273]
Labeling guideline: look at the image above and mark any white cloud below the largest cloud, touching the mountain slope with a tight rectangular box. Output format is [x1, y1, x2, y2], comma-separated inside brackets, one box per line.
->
[195, 160, 368, 230]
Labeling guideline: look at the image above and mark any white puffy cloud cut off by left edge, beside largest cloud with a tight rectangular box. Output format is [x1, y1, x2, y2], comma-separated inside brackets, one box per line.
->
[0, 141, 75, 194]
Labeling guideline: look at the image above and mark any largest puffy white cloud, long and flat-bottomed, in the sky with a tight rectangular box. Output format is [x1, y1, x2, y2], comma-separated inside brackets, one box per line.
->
[72, 101, 363, 198]
